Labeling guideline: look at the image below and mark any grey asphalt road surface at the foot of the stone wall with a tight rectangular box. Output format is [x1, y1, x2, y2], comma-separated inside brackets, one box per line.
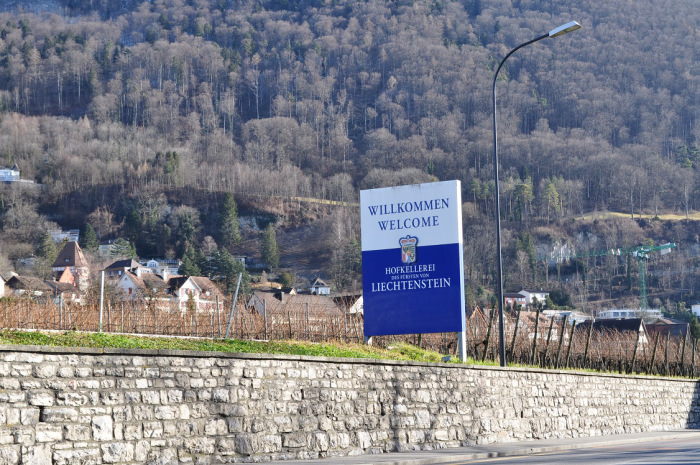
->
[443, 439, 700, 465]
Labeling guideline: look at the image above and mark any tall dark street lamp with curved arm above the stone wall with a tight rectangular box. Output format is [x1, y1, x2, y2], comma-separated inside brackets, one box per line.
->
[493, 21, 581, 367]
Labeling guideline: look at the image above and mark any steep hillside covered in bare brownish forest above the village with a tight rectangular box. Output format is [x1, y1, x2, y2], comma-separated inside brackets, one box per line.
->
[0, 0, 700, 308]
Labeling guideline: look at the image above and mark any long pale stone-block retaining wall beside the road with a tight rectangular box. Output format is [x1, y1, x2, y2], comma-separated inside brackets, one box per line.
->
[0, 346, 700, 465]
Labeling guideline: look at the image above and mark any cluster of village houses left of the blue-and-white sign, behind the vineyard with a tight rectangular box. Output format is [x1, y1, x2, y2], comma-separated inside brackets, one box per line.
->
[0, 230, 362, 326]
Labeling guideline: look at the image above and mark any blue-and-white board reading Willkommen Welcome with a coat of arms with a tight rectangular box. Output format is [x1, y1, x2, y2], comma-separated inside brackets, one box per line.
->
[360, 181, 465, 337]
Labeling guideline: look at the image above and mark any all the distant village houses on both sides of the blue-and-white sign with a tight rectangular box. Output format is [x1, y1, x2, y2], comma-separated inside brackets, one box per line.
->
[0, 226, 700, 344]
